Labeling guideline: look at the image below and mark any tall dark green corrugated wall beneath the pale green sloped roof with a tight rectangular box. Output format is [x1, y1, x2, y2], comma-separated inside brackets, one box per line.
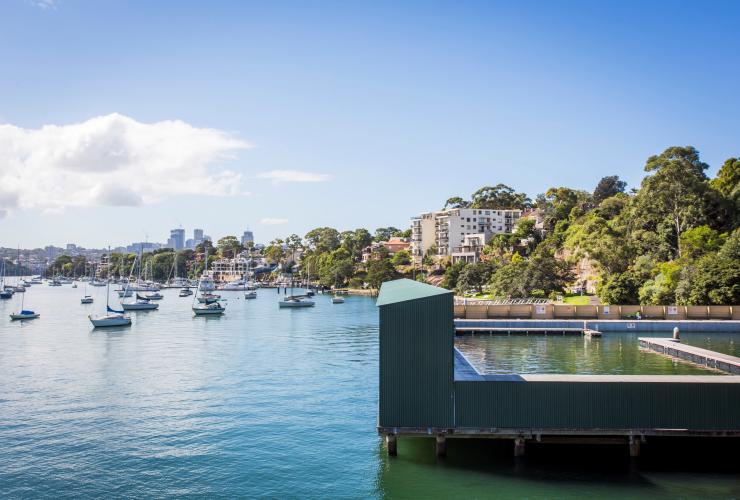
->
[378, 294, 455, 427]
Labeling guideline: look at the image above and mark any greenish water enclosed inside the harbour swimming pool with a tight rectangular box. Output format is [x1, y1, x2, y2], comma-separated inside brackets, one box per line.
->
[455, 332, 740, 375]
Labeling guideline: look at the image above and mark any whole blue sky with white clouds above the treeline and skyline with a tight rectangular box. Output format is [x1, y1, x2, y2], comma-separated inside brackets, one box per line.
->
[0, 0, 740, 248]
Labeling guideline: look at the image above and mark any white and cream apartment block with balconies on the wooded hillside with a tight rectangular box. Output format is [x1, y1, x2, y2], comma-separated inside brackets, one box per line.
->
[411, 208, 522, 260]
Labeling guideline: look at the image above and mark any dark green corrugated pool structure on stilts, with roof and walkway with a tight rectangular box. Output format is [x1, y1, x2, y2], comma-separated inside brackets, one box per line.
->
[377, 280, 740, 457]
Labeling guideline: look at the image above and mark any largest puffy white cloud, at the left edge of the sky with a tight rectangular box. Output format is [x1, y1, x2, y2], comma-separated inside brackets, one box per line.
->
[0, 113, 249, 214]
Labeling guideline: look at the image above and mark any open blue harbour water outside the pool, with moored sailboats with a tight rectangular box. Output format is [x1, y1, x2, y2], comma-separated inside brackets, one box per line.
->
[0, 285, 740, 498]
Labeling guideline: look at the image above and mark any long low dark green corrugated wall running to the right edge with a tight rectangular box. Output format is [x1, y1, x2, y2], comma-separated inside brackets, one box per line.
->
[455, 381, 740, 430]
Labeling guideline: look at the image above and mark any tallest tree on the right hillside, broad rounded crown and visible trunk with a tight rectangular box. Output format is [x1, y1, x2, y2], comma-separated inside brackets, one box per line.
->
[632, 146, 708, 257]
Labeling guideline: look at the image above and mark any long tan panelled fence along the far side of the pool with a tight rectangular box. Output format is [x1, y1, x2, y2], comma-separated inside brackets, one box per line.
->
[455, 301, 740, 320]
